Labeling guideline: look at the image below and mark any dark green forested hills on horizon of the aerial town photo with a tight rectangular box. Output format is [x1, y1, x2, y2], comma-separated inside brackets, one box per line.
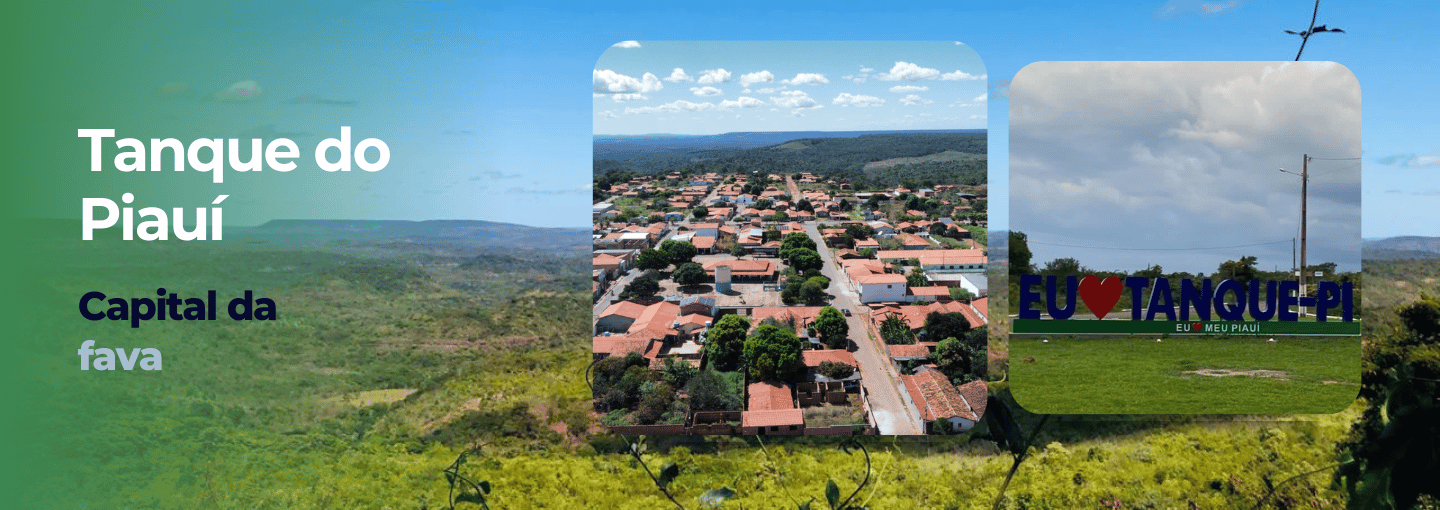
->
[595, 130, 986, 189]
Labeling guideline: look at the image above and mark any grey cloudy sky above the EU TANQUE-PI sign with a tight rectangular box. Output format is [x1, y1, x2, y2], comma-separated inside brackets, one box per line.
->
[1009, 62, 1361, 272]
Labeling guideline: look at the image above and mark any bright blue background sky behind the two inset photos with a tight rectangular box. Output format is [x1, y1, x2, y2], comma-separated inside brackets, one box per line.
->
[73, 0, 1440, 230]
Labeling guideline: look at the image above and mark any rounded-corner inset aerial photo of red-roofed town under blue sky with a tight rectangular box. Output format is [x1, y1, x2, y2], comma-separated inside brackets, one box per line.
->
[588, 42, 995, 435]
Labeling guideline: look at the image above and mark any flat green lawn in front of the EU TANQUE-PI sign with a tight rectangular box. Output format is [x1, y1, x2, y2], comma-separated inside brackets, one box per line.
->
[1009, 336, 1361, 415]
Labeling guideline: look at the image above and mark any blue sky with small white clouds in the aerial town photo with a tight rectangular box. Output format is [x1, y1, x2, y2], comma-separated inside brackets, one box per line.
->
[592, 40, 988, 134]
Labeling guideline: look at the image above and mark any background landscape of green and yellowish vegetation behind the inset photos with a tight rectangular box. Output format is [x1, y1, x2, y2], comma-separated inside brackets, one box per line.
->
[25, 220, 1440, 509]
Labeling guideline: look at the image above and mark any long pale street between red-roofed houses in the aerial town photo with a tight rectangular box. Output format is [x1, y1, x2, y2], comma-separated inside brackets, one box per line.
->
[805, 223, 924, 435]
